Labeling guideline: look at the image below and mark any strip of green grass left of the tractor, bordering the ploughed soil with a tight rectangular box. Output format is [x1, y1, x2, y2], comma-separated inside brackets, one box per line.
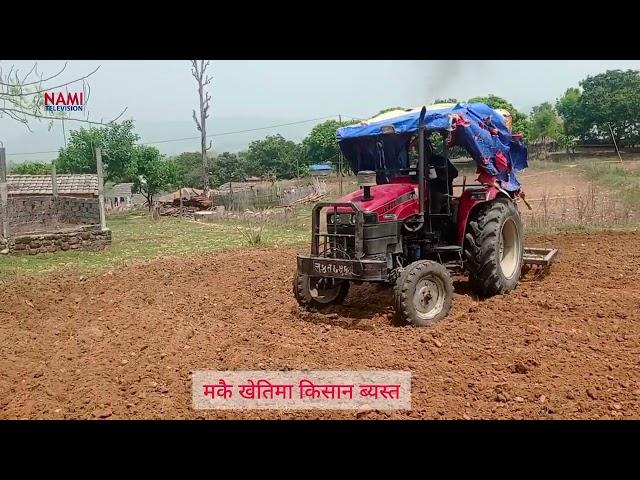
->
[0, 210, 310, 278]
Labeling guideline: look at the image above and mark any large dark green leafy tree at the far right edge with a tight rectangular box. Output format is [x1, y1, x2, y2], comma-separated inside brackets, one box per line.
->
[557, 70, 640, 145]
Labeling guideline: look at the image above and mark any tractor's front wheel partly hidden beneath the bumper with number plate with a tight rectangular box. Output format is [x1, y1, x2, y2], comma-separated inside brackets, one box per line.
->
[293, 272, 350, 308]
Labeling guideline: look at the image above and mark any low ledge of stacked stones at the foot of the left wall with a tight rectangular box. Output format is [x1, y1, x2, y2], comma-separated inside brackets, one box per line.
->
[0, 225, 111, 255]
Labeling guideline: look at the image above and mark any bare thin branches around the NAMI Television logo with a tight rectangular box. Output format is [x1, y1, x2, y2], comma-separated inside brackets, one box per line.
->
[0, 62, 127, 131]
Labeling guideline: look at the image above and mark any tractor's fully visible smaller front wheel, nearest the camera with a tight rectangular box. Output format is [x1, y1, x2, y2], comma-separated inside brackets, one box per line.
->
[394, 260, 453, 327]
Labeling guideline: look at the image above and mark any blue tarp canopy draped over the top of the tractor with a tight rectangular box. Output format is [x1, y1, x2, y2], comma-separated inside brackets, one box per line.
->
[336, 103, 528, 191]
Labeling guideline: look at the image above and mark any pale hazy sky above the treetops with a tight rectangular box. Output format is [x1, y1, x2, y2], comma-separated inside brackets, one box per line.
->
[0, 60, 640, 162]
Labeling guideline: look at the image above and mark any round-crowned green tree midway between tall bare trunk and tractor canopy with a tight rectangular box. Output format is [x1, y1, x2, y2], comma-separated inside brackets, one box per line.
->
[246, 134, 306, 178]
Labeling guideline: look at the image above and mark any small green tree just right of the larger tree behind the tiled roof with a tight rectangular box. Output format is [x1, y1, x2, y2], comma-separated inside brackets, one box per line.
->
[132, 145, 176, 210]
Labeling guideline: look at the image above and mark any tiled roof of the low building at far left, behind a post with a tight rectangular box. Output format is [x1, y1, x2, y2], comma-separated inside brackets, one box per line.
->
[7, 174, 98, 196]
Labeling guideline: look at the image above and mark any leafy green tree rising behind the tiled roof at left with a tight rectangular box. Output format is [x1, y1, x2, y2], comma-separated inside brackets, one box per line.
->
[56, 120, 140, 182]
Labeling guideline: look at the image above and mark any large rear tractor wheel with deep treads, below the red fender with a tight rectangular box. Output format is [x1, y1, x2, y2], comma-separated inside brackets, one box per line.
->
[464, 198, 524, 297]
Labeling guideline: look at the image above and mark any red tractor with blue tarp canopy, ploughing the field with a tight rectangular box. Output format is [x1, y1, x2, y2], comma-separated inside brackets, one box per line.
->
[293, 104, 557, 326]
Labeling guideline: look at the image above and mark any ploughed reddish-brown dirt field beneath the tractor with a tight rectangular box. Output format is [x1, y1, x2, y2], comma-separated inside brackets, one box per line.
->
[0, 232, 640, 419]
